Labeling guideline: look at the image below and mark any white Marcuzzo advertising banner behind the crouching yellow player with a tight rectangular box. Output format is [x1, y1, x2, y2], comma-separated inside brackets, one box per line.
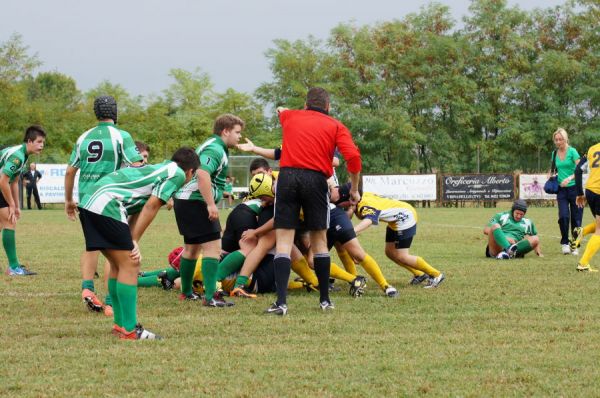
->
[363, 174, 437, 200]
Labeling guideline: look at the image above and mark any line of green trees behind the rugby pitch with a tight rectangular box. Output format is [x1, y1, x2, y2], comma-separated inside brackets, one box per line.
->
[0, 0, 600, 177]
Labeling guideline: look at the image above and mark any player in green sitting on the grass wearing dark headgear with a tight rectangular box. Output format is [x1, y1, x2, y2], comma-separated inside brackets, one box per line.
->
[483, 199, 543, 260]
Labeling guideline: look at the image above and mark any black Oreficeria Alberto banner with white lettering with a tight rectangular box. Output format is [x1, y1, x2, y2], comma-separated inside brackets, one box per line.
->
[442, 174, 515, 200]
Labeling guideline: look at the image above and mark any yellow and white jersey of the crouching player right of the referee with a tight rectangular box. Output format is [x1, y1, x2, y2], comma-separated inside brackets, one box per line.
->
[355, 192, 417, 231]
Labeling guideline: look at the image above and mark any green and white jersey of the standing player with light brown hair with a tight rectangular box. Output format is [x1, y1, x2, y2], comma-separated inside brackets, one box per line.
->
[175, 134, 229, 203]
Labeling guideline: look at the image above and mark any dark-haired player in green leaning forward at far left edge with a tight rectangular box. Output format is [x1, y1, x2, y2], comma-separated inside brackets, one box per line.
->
[0, 126, 46, 276]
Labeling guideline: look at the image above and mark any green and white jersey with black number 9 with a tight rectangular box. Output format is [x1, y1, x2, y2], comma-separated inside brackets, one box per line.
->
[69, 122, 143, 199]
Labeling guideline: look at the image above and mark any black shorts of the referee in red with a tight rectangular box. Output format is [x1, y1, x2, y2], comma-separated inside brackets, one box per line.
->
[275, 167, 329, 231]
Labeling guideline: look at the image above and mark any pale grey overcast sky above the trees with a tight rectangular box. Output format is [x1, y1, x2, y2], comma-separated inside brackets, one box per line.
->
[0, 0, 564, 95]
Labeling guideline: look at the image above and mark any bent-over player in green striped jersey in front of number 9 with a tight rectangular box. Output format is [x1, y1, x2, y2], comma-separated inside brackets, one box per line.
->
[79, 148, 199, 340]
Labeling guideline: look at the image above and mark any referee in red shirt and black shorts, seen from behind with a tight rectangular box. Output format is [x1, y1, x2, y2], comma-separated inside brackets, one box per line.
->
[267, 87, 362, 315]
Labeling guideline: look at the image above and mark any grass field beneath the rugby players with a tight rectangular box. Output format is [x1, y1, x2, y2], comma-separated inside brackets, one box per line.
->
[0, 208, 600, 397]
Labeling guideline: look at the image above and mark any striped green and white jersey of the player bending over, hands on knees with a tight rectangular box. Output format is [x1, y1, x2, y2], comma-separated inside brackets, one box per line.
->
[79, 160, 185, 223]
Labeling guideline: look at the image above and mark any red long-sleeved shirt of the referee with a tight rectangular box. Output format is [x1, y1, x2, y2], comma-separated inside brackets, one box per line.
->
[279, 109, 362, 177]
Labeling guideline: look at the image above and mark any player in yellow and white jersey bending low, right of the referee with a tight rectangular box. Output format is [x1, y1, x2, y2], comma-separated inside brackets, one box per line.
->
[354, 192, 445, 289]
